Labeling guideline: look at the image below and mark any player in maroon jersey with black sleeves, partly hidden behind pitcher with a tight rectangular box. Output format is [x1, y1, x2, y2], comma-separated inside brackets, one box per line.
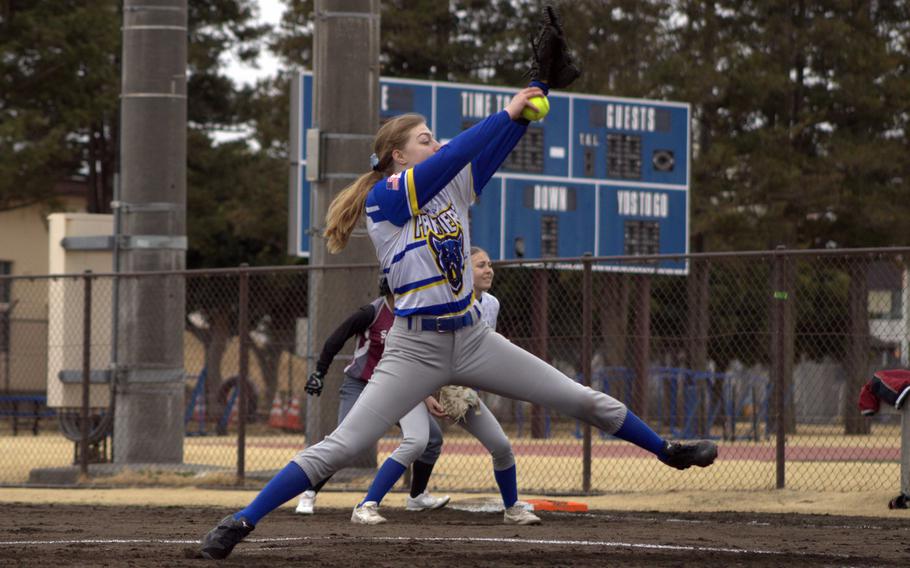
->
[295, 277, 449, 524]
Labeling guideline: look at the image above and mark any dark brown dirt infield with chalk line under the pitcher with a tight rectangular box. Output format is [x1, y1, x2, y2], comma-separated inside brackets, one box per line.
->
[0, 503, 910, 568]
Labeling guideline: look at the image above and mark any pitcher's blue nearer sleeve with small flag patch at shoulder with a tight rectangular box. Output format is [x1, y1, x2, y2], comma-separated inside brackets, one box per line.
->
[367, 111, 523, 227]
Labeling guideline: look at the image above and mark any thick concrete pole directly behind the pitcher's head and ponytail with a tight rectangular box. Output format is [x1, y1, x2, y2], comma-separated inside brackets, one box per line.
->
[306, 0, 380, 467]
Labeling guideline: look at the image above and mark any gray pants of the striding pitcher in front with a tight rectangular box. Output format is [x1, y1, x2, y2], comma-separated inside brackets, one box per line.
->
[292, 317, 627, 484]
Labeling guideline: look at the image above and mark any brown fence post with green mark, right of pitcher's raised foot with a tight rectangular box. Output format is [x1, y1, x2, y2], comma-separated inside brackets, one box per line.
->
[770, 245, 789, 489]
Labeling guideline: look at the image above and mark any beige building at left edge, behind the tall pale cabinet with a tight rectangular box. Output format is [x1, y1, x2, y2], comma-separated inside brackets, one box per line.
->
[0, 182, 86, 393]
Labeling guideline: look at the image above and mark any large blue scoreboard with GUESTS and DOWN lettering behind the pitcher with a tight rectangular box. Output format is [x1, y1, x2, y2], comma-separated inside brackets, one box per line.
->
[289, 73, 690, 274]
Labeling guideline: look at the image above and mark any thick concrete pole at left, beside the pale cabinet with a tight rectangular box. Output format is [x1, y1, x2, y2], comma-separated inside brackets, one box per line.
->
[113, 0, 187, 464]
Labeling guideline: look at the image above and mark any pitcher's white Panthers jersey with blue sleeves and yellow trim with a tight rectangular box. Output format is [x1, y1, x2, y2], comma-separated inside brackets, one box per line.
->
[366, 111, 527, 316]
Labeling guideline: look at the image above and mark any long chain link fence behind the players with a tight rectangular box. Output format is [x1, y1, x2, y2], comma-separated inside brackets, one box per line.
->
[0, 249, 910, 494]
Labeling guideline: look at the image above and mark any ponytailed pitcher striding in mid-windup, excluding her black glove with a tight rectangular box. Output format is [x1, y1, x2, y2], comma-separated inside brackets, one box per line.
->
[201, 84, 717, 559]
